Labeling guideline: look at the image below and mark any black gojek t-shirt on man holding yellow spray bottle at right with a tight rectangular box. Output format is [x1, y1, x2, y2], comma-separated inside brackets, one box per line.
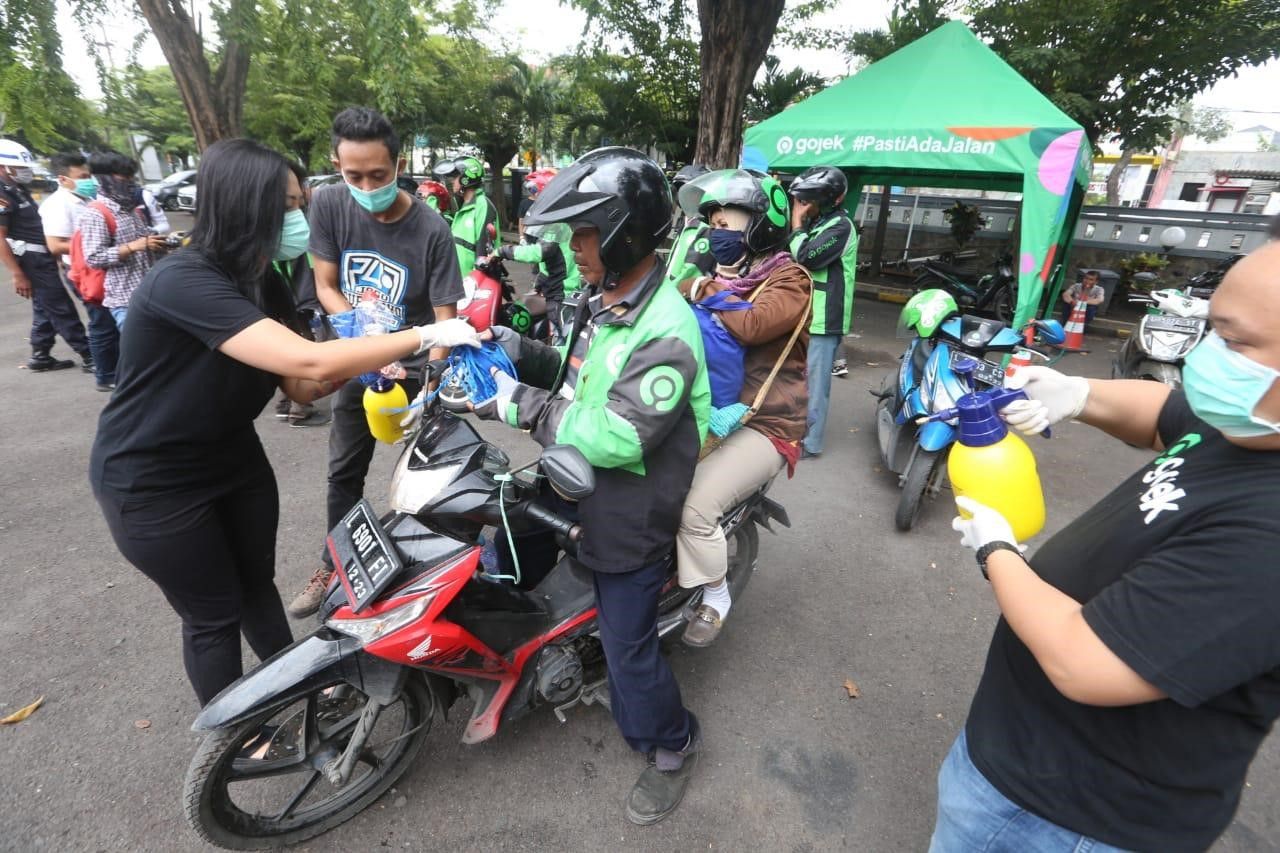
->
[965, 392, 1280, 850]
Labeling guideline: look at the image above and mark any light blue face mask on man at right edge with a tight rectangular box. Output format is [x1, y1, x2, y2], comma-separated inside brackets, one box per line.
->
[1183, 332, 1280, 438]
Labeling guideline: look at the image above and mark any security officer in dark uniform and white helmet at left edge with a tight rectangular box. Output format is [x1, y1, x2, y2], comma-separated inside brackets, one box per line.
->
[0, 140, 93, 373]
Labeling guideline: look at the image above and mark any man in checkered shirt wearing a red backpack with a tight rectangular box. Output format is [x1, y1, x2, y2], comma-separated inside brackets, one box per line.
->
[73, 151, 165, 333]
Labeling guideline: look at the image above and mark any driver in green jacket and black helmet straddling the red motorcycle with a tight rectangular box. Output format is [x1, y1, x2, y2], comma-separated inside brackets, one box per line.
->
[476, 147, 710, 825]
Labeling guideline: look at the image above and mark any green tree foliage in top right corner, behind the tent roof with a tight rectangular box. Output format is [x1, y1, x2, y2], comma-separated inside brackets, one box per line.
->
[833, 0, 1280, 150]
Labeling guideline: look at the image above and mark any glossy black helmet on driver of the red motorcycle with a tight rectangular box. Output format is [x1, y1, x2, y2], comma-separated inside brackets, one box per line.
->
[525, 147, 671, 275]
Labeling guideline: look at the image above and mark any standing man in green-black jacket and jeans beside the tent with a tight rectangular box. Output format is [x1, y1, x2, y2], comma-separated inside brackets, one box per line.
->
[791, 167, 858, 457]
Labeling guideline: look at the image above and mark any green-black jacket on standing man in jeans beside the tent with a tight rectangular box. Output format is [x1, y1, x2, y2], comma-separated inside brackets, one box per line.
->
[791, 209, 858, 334]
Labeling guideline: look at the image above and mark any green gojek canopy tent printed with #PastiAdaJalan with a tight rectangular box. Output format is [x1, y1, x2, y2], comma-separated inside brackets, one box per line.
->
[742, 20, 1093, 328]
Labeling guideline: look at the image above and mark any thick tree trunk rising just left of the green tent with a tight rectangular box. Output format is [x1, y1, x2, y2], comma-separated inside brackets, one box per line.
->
[694, 0, 785, 169]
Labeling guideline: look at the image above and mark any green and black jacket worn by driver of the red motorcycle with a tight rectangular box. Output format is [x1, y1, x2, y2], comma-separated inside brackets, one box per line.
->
[499, 265, 710, 573]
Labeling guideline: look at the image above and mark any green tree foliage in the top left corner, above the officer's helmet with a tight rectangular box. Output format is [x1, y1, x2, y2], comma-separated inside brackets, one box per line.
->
[0, 0, 96, 152]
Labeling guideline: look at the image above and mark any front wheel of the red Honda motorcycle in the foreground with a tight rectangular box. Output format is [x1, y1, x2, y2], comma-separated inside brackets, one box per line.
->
[183, 674, 435, 850]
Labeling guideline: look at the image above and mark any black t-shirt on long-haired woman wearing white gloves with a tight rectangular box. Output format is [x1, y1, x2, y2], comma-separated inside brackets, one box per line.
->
[90, 250, 279, 494]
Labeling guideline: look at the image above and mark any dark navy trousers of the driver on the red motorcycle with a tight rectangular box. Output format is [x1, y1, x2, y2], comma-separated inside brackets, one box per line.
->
[497, 500, 694, 753]
